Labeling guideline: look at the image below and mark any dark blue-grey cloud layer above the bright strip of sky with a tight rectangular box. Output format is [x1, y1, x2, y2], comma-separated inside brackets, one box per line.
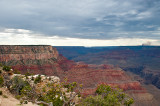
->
[0, 0, 160, 39]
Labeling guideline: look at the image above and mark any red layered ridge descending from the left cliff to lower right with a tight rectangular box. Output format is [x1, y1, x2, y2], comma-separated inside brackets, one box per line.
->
[58, 56, 159, 106]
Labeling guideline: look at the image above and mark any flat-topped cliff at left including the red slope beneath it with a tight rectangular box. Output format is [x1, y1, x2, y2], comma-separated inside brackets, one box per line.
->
[0, 45, 59, 74]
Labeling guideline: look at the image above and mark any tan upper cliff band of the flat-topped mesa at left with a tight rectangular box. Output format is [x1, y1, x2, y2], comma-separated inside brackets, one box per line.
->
[0, 46, 58, 62]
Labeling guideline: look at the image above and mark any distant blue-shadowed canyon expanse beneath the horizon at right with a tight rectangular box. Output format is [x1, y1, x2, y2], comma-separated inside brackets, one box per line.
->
[57, 46, 160, 89]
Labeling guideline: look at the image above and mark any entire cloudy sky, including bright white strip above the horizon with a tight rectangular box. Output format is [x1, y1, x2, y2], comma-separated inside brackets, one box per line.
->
[0, 0, 160, 46]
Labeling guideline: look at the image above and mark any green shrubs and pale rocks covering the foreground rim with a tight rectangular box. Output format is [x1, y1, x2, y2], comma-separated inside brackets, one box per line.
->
[0, 63, 134, 106]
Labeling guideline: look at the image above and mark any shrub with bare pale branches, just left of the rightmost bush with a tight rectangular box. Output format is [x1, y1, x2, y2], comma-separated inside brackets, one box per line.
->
[35, 82, 80, 106]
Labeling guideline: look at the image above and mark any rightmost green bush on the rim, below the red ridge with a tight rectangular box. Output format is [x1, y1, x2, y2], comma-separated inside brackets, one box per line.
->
[79, 85, 134, 106]
